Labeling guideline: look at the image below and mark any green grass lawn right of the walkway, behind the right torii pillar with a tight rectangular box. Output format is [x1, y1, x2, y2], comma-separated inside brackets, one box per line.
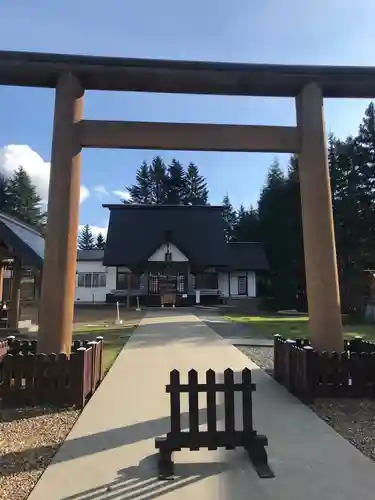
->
[226, 315, 375, 340]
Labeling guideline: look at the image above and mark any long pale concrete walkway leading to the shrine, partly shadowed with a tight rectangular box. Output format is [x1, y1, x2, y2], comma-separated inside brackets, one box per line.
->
[29, 311, 375, 500]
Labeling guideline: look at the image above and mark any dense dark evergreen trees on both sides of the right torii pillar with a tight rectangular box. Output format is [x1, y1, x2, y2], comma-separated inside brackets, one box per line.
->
[223, 103, 375, 312]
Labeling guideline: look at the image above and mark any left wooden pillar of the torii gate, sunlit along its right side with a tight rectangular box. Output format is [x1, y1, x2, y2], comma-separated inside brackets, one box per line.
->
[38, 73, 84, 354]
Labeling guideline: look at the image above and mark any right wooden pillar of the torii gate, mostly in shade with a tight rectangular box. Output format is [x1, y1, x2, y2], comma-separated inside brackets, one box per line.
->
[296, 83, 343, 352]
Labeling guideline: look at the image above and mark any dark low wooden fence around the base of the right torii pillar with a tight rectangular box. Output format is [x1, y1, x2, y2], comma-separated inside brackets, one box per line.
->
[274, 335, 375, 404]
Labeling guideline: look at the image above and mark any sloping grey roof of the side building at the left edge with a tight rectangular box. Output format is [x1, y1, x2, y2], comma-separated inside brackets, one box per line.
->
[0, 212, 44, 268]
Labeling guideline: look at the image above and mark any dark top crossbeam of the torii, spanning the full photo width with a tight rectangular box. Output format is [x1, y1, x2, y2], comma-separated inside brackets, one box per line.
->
[0, 51, 375, 98]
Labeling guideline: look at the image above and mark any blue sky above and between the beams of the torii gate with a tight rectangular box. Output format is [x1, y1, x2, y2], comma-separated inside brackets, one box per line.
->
[0, 0, 375, 235]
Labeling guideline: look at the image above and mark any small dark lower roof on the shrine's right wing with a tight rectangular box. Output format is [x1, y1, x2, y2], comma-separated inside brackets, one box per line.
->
[228, 242, 268, 271]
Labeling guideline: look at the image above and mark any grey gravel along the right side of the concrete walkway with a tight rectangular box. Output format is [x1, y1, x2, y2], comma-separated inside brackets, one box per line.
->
[236, 346, 375, 461]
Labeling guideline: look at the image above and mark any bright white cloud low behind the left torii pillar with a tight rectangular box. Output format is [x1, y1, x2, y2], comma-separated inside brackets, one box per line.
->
[0, 144, 90, 203]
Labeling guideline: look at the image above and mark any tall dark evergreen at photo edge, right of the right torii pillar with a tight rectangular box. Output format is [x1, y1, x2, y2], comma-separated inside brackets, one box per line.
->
[331, 103, 375, 312]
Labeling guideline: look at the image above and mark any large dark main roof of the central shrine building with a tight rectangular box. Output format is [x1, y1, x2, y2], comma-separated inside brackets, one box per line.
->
[103, 204, 229, 267]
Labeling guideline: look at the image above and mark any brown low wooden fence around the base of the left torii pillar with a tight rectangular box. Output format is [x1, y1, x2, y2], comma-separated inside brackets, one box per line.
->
[0, 337, 103, 408]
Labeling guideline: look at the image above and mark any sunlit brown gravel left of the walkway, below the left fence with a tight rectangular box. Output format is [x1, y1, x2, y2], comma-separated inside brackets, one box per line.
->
[0, 406, 80, 500]
